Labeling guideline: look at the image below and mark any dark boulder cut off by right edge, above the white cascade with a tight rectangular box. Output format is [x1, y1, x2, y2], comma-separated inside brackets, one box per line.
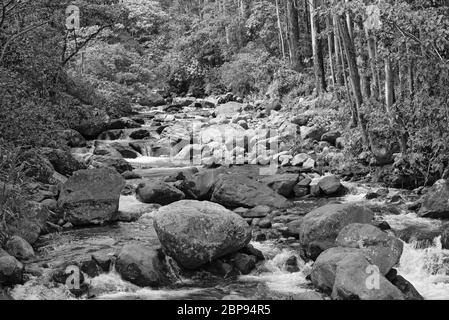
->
[418, 180, 449, 219]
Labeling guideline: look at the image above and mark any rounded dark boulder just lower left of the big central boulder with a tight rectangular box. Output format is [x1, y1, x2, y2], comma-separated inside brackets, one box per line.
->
[115, 244, 169, 287]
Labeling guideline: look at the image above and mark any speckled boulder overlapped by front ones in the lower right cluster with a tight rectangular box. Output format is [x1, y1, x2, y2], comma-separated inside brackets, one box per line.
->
[335, 223, 404, 275]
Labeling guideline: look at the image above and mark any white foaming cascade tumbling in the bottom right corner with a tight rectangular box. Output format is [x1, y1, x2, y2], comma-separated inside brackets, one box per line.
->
[398, 237, 449, 300]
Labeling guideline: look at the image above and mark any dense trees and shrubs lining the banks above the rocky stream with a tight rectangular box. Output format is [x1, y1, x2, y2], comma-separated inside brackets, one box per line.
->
[0, 0, 449, 183]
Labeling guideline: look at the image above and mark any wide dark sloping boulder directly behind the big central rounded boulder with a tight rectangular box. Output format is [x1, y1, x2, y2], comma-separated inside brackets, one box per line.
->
[211, 174, 289, 208]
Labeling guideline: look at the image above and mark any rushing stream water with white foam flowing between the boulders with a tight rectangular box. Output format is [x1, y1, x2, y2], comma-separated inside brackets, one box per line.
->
[11, 109, 449, 300]
